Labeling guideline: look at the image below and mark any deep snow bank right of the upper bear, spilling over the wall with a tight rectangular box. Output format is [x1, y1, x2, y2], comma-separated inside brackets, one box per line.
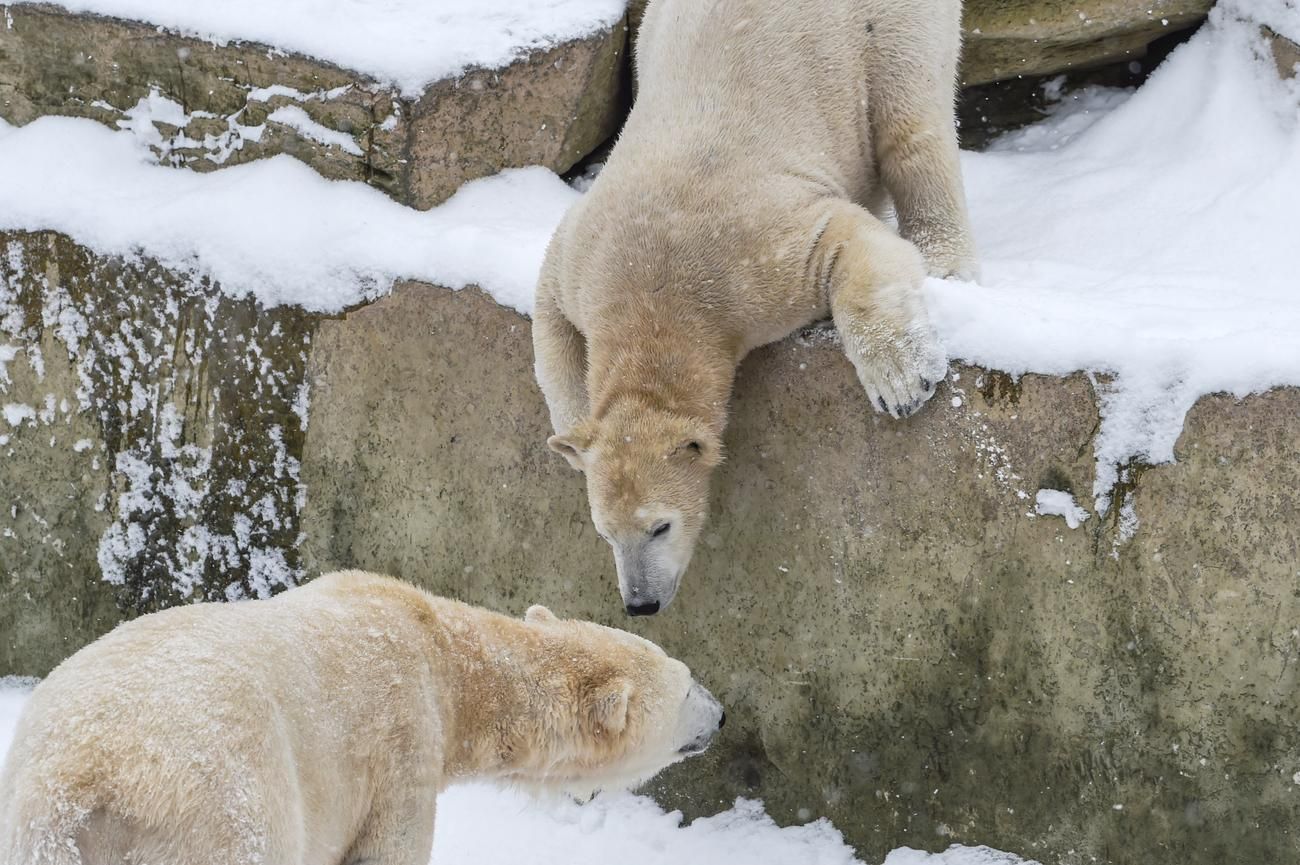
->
[927, 3, 1300, 511]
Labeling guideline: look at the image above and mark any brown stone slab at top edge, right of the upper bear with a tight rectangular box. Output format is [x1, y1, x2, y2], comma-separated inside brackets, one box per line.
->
[959, 0, 1214, 86]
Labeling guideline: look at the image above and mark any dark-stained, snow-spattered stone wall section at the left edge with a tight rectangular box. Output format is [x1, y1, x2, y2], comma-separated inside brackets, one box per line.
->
[0, 233, 316, 675]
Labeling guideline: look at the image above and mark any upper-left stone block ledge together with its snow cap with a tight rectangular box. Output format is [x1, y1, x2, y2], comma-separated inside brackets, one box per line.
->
[0, 0, 627, 209]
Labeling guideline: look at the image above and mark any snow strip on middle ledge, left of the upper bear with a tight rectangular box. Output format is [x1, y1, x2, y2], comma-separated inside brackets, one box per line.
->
[0, 117, 577, 312]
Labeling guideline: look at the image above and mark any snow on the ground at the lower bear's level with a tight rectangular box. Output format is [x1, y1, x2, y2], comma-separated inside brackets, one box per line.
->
[0, 678, 1037, 865]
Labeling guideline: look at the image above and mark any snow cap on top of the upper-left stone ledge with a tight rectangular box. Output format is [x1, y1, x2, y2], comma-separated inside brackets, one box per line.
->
[7, 0, 627, 98]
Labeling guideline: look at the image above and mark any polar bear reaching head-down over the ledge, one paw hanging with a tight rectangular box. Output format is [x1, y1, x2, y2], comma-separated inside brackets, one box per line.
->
[533, 0, 976, 615]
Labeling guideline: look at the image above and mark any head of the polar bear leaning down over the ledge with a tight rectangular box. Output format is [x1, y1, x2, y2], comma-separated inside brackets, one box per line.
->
[549, 407, 722, 615]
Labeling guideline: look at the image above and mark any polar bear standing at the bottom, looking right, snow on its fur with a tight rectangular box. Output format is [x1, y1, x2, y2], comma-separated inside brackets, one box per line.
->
[0, 571, 723, 865]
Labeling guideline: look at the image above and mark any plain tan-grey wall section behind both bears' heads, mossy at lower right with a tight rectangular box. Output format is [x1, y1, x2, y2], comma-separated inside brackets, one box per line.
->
[303, 285, 1300, 865]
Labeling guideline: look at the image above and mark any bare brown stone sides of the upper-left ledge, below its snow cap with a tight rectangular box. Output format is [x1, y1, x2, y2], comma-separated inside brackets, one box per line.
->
[0, 5, 627, 208]
